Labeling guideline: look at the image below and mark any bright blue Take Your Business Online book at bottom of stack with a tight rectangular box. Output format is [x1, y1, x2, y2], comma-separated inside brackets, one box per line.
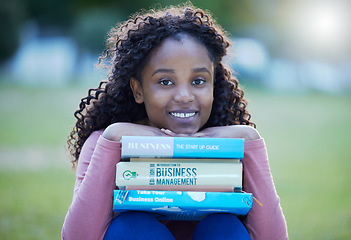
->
[113, 190, 253, 221]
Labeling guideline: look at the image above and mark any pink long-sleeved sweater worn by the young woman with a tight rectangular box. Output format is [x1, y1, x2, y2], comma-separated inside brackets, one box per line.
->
[62, 131, 288, 240]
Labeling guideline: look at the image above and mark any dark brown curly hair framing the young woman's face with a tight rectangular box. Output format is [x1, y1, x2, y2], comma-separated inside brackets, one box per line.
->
[67, 3, 255, 163]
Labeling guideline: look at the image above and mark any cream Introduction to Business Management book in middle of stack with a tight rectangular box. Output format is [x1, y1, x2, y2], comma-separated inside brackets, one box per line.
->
[116, 162, 242, 189]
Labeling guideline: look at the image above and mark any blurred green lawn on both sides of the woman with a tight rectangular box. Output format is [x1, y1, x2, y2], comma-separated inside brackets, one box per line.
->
[0, 86, 351, 239]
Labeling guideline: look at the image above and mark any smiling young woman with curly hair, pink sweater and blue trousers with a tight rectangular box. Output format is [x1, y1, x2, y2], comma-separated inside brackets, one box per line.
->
[62, 4, 288, 239]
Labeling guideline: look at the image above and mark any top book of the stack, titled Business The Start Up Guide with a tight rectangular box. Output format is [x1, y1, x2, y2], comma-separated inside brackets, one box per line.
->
[121, 136, 244, 159]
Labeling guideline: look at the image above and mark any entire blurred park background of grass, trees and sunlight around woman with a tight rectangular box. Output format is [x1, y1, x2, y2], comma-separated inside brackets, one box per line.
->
[0, 0, 351, 240]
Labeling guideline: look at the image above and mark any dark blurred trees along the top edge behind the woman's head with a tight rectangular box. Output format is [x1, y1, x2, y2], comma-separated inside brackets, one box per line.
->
[0, 0, 274, 59]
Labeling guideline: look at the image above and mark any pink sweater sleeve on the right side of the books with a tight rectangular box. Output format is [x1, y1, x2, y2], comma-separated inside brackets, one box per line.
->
[243, 139, 288, 240]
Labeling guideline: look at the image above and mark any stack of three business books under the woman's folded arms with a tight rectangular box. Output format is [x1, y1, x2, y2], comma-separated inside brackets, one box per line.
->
[113, 136, 252, 220]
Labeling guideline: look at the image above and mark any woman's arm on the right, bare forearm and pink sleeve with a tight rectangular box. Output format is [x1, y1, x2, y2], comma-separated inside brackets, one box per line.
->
[170, 125, 288, 240]
